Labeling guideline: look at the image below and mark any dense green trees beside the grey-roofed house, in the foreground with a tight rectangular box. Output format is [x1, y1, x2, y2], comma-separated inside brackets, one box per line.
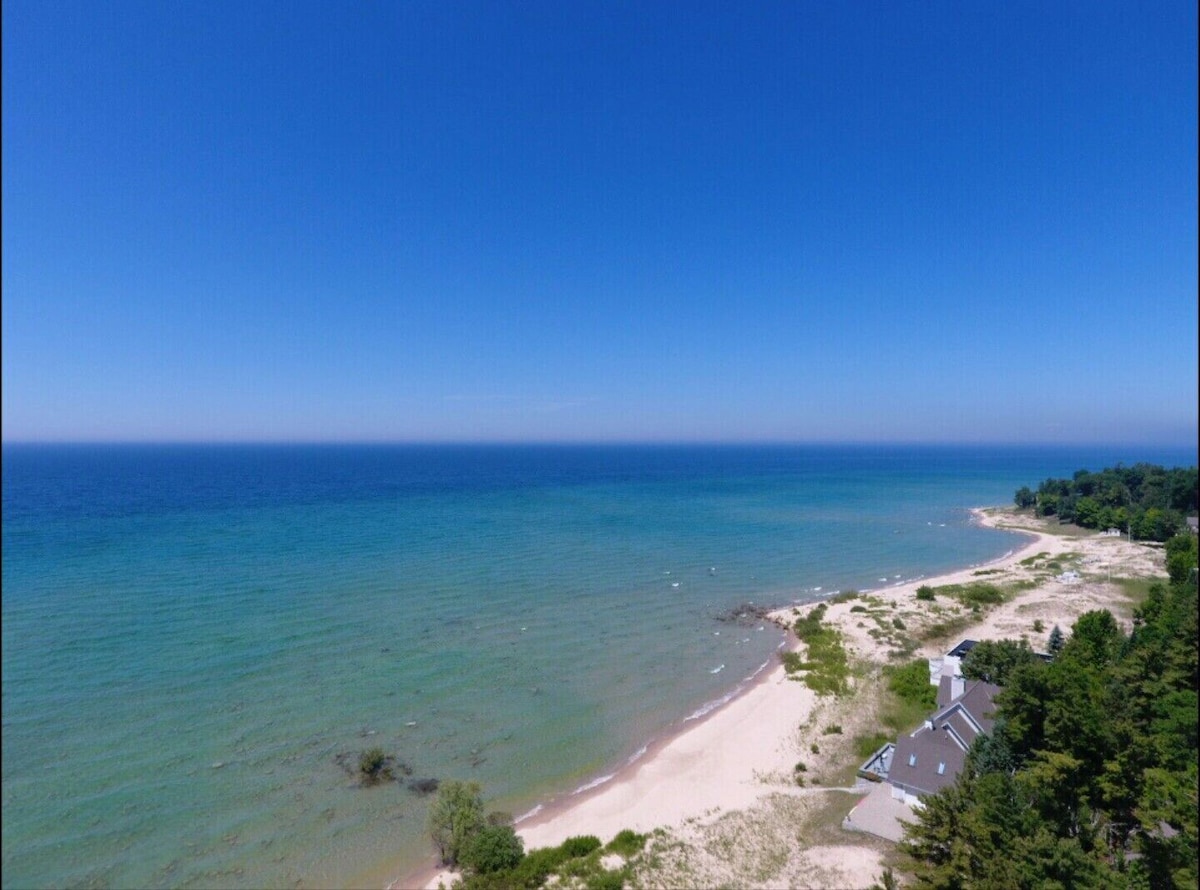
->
[901, 534, 1200, 890]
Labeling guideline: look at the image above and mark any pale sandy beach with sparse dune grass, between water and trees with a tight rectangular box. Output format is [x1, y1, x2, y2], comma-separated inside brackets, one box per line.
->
[391, 509, 1164, 888]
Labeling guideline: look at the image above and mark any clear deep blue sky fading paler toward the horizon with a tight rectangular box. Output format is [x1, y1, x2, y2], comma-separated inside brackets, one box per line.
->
[2, 0, 1198, 444]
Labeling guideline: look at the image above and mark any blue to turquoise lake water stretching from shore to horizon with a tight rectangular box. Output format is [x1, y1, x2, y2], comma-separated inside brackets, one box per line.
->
[2, 446, 1195, 888]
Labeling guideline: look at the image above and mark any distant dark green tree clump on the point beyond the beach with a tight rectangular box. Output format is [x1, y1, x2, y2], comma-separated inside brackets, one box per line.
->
[1013, 463, 1198, 541]
